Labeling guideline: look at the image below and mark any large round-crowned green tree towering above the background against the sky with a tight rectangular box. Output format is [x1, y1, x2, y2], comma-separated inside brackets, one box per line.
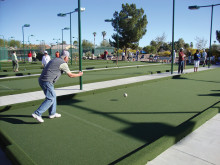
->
[110, 3, 148, 50]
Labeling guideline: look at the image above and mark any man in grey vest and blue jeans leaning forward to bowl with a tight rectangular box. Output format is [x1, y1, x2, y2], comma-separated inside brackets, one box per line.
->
[32, 51, 83, 123]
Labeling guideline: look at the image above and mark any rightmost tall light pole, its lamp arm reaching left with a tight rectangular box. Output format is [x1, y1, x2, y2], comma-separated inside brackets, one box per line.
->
[188, 4, 220, 68]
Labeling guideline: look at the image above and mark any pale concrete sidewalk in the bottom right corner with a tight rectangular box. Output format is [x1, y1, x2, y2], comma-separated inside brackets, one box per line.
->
[147, 114, 220, 165]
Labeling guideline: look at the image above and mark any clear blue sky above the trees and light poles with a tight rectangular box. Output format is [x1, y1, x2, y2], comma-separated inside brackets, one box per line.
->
[0, 0, 220, 47]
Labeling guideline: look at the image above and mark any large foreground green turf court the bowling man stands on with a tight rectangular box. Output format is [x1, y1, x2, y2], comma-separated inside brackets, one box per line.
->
[0, 68, 220, 165]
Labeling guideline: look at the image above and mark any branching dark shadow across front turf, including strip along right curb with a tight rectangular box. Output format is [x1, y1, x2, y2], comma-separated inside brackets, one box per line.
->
[57, 98, 220, 165]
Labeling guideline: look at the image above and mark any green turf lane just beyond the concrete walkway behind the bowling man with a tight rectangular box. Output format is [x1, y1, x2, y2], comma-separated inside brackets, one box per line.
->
[0, 65, 191, 96]
